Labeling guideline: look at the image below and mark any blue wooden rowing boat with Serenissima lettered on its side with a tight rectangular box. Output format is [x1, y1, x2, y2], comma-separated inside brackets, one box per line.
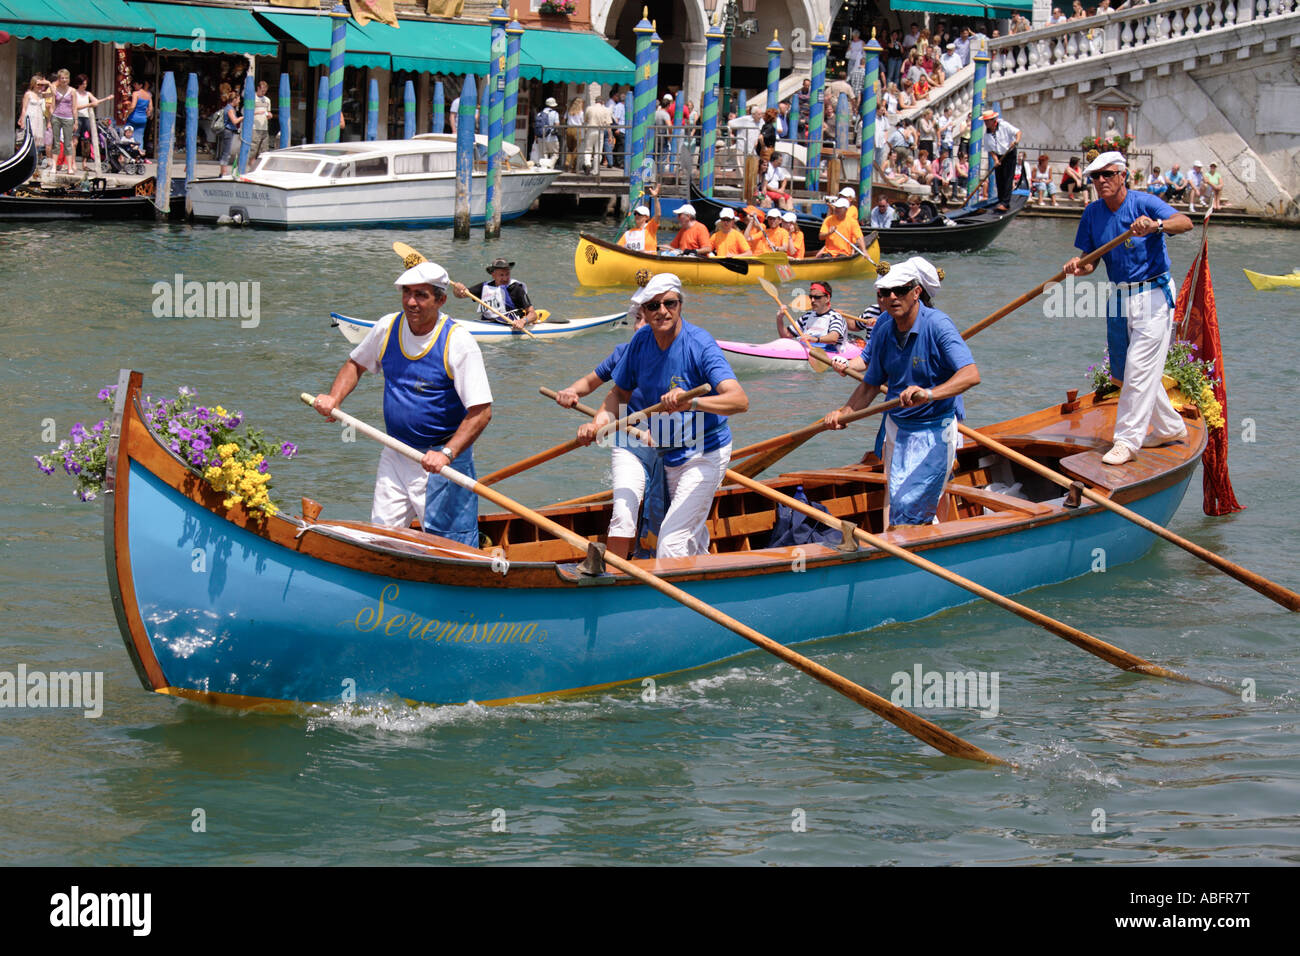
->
[105, 371, 1205, 709]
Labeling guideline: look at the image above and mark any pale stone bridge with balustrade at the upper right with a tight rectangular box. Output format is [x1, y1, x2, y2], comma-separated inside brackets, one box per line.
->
[985, 0, 1300, 219]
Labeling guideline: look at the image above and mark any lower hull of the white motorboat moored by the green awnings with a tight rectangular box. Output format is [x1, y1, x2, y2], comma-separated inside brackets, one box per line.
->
[190, 169, 559, 229]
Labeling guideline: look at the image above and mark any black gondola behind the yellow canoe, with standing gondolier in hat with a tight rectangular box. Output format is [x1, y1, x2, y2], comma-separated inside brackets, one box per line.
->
[690, 183, 1028, 254]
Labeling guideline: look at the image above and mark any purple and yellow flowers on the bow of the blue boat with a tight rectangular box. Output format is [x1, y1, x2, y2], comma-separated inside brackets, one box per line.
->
[33, 385, 298, 515]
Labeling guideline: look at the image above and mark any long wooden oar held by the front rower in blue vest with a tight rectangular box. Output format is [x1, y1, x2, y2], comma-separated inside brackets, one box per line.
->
[302, 393, 1014, 766]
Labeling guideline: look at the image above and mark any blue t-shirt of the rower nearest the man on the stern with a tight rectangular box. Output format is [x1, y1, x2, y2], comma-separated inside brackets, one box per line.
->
[863, 303, 975, 425]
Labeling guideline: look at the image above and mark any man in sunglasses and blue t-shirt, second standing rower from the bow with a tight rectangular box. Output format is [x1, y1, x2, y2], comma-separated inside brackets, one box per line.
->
[577, 272, 749, 558]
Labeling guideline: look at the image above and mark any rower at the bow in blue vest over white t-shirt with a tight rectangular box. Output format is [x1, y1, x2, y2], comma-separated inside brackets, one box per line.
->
[312, 261, 491, 548]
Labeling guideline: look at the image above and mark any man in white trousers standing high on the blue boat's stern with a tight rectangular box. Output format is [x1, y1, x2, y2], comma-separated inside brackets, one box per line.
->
[1065, 152, 1192, 464]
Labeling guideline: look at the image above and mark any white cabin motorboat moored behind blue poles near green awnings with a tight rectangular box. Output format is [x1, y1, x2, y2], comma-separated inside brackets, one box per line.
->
[189, 133, 559, 229]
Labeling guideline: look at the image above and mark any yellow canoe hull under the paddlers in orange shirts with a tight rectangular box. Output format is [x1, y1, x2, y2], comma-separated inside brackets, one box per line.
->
[573, 233, 880, 286]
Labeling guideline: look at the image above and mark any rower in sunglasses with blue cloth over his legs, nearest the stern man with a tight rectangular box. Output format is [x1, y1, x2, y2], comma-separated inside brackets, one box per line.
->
[826, 256, 979, 528]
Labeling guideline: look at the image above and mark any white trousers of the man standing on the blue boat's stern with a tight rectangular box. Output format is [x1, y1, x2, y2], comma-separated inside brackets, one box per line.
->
[1115, 287, 1186, 451]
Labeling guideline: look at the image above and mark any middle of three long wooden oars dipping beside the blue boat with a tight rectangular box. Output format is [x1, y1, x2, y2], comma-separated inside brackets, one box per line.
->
[553, 387, 1201, 693]
